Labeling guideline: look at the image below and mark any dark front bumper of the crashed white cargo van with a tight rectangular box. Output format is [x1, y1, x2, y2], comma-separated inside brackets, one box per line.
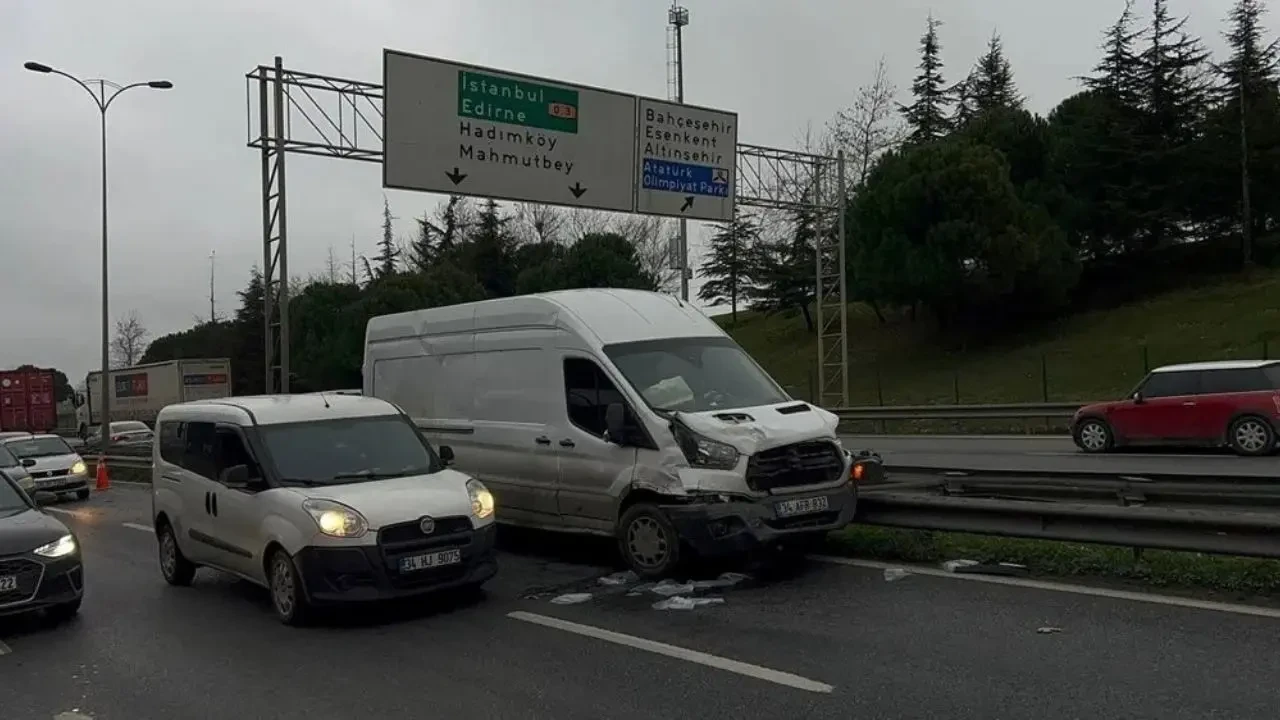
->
[663, 483, 858, 557]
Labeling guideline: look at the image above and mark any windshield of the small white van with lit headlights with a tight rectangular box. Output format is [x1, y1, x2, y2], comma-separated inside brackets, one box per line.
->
[260, 415, 444, 484]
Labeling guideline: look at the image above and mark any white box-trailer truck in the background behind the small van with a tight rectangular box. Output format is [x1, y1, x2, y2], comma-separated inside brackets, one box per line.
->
[76, 357, 232, 438]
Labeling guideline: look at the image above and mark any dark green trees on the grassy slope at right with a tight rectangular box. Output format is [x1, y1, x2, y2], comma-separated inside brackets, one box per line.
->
[700, 0, 1280, 338]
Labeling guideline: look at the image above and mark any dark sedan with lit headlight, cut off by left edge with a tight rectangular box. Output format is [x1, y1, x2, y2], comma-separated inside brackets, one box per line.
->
[0, 474, 84, 620]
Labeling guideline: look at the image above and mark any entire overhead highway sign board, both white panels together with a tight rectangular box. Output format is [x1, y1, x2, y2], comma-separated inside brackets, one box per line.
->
[383, 50, 737, 220]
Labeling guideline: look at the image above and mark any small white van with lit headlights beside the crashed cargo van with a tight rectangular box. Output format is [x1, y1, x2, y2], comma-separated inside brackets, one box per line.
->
[151, 393, 498, 624]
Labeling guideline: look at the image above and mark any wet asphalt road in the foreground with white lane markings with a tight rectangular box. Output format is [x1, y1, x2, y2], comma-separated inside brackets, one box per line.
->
[0, 486, 1280, 720]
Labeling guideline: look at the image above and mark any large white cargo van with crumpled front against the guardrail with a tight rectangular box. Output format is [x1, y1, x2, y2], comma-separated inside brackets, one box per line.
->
[364, 288, 879, 577]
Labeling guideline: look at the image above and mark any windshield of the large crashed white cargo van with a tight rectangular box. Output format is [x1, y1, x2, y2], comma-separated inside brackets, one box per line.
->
[604, 337, 790, 413]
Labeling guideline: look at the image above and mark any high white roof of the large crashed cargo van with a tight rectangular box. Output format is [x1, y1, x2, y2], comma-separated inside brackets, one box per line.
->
[365, 288, 726, 346]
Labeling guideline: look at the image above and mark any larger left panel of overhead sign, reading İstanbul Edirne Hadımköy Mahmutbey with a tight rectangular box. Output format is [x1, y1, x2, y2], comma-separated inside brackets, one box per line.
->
[383, 50, 640, 213]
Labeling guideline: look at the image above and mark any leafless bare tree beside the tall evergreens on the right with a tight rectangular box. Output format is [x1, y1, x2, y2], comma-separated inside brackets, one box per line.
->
[831, 58, 908, 187]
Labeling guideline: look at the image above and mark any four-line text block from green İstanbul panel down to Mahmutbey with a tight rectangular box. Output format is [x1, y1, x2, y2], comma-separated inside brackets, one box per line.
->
[458, 70, 579, 176]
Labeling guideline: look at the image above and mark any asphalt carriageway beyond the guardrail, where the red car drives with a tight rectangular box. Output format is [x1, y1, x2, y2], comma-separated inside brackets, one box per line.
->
[842, 436, 1280, 478]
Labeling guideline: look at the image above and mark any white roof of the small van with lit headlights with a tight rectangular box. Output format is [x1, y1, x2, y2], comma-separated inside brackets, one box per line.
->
[156, 393, 399, 425]
